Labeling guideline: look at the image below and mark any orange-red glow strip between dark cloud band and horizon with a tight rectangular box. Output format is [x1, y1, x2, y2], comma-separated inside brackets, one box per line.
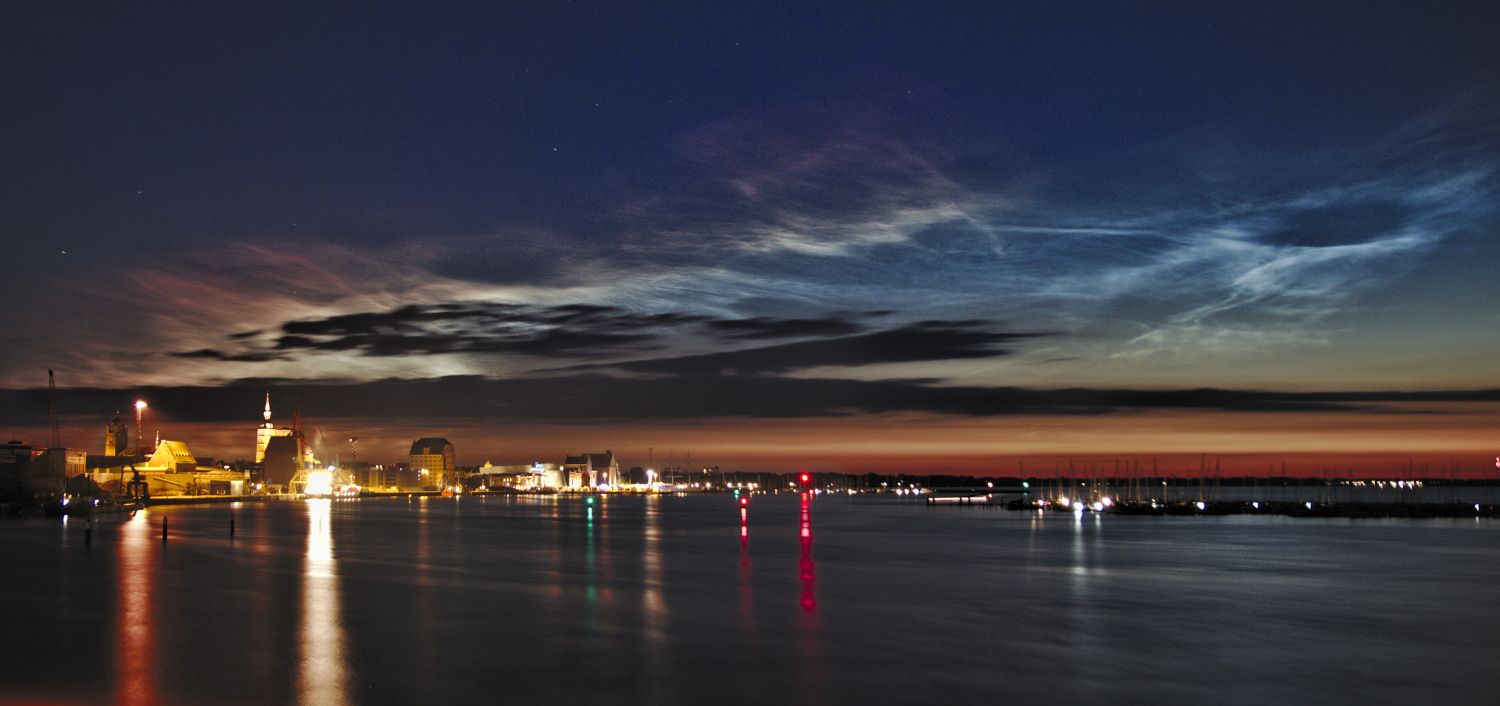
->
[38, 403, 1500, 477]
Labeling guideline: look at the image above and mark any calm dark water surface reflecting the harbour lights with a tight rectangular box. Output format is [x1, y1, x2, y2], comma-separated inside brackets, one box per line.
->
[0, 495, 1500, 705]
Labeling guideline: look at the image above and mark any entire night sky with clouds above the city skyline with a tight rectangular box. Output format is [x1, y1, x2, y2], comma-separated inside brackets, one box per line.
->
[0, 1, 1500, 472]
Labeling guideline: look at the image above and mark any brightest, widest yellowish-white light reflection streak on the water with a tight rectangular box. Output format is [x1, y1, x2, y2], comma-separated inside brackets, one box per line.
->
[297, 499, 348, 705]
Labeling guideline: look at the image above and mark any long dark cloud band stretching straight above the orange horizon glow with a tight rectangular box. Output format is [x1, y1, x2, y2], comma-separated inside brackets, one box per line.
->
[14, 375, 1500, 426]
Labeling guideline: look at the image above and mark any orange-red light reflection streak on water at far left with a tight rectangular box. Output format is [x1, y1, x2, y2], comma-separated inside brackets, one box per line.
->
[114, 513, 158, 706]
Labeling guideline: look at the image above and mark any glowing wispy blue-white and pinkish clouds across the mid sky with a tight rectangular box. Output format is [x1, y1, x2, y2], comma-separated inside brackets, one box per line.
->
[14, 87, 1500, 384]
